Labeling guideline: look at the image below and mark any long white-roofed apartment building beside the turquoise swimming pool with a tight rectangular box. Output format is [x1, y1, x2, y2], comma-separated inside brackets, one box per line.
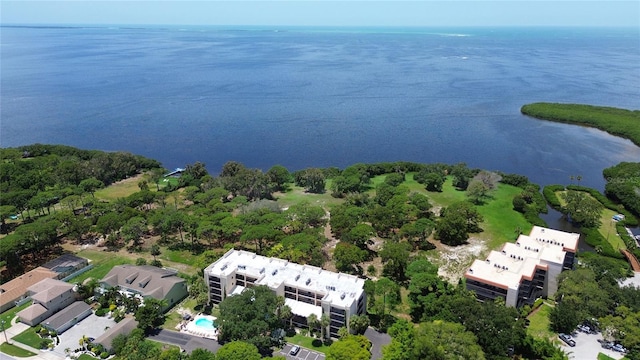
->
[204, 250, 367, 337]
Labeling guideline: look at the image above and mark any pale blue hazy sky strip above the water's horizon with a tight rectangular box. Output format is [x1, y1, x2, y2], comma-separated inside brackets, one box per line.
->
[0, 0, 640, 29]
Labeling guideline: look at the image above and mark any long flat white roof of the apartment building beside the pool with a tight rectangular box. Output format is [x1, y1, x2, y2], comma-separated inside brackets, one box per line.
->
[205, 249, 364, 307]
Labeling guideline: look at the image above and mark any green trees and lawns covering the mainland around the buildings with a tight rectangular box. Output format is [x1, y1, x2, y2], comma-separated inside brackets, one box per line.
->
[0, 139, 640, 359]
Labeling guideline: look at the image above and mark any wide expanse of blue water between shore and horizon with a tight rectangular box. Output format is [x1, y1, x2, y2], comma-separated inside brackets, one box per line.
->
[0, 27, 640, 189]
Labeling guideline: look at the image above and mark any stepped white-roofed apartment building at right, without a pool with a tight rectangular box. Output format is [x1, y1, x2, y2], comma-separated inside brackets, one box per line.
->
[464, 226, 580, 307]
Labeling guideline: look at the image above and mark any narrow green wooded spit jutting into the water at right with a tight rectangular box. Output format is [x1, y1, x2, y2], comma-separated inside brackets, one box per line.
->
[520, 102, 640, 146]
